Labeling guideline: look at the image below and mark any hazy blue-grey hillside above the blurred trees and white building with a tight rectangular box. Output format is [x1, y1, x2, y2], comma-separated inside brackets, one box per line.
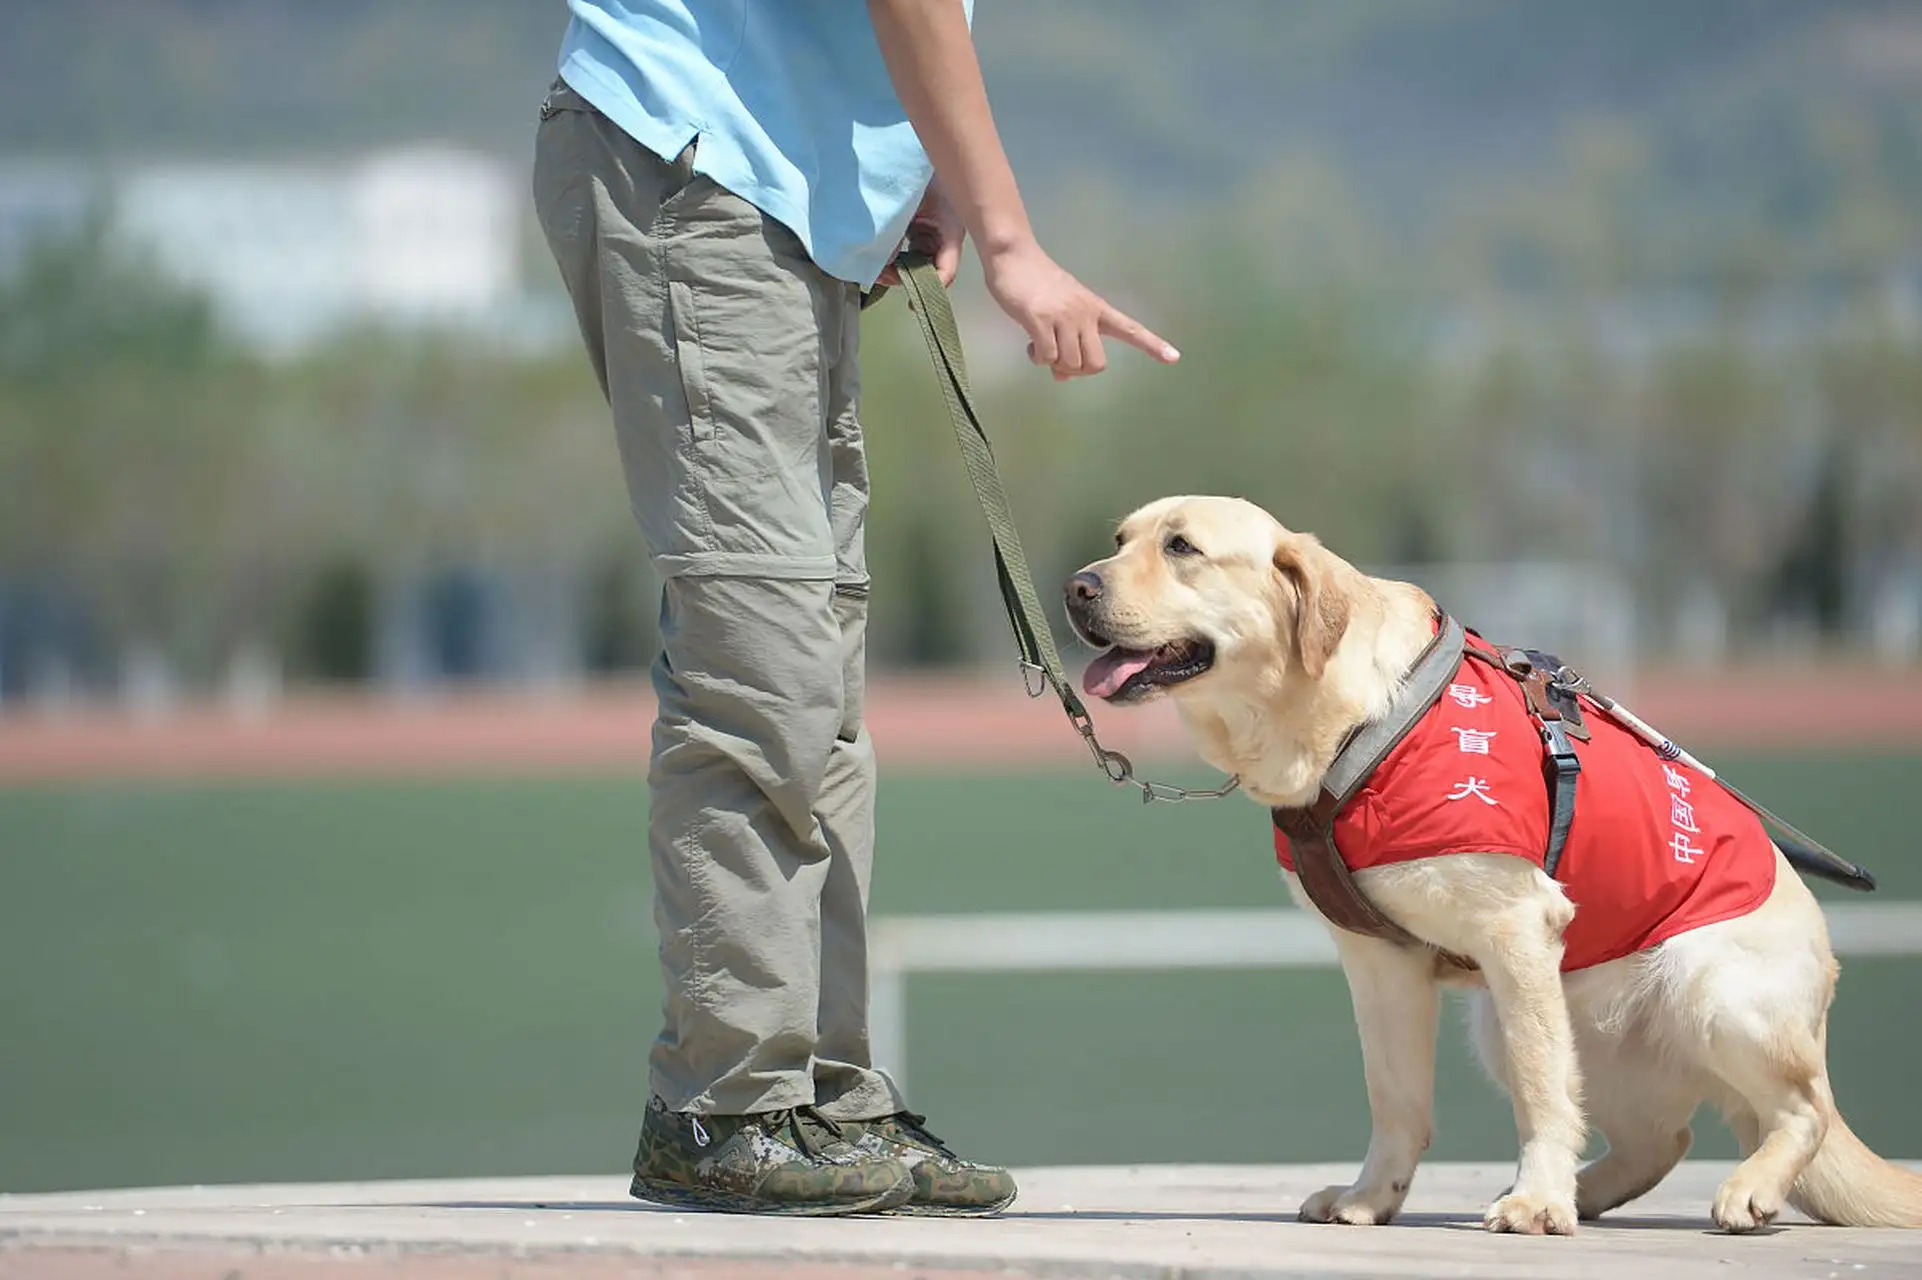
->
[15, 0, 1922, 242]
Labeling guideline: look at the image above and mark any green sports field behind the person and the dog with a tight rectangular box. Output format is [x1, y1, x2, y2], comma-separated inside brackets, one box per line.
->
[0, 755, 1922, 1192]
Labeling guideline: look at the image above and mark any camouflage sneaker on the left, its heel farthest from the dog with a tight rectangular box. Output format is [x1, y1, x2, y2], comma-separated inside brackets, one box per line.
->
[628, 1097, 915, 1217]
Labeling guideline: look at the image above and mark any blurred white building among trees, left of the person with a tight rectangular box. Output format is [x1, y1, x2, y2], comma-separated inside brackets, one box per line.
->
[0, 146, 565, 354]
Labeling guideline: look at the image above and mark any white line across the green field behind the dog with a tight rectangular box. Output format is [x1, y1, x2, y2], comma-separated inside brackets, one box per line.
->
[869, 901, 1922, 1088]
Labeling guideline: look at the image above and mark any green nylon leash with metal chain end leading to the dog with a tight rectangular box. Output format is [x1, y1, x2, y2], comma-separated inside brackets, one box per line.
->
[896, 254, 1240, 803]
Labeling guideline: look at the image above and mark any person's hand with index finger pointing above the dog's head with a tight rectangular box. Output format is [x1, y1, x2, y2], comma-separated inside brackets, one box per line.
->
[982, 240, 1182, 382]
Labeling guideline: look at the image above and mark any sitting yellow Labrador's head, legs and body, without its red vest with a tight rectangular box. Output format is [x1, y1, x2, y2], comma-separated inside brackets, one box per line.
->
[1067, 498, 1922, 1234]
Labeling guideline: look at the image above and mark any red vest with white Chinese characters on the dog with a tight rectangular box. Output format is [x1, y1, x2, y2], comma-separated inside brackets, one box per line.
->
[1274, 636, 1776, 972]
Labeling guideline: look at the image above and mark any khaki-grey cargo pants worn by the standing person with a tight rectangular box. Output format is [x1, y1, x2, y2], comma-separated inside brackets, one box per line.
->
[534, 85, 901, 1119]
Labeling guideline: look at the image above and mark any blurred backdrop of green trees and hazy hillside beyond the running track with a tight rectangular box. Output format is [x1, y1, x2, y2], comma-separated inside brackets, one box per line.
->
[0, 0, 1922, 696]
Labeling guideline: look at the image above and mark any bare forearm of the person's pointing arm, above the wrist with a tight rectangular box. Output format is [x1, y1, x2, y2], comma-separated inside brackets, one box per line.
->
[867, 0, 1034, 258]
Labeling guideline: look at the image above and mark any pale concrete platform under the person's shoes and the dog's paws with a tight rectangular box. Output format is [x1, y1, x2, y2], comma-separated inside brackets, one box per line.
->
[0, 1163, 1922, 1280]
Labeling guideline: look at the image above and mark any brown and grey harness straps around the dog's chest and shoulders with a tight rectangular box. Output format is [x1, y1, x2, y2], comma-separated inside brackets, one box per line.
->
[1272, 613, 1589, 971]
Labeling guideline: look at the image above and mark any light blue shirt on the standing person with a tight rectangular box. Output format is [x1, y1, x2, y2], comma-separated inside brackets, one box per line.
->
[561, 0, 974, 288]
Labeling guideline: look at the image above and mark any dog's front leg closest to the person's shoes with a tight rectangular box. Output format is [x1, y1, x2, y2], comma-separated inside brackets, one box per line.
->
[1301, 930, 1440, 1226]
